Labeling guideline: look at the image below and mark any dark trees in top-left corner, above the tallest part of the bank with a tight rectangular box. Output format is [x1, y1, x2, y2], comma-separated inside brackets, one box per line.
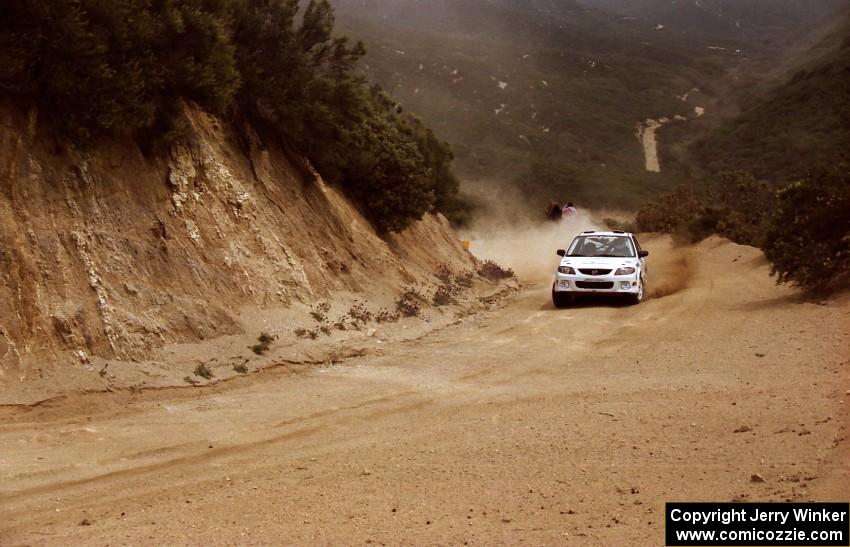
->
[0, 0, 239, 142]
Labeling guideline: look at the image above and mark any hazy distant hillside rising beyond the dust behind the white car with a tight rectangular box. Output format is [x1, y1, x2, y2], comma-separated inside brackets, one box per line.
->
[335, 0, 737, 207]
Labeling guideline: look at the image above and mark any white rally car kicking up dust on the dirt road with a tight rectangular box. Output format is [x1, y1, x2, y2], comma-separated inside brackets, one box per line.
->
[552, 231, 649, 308]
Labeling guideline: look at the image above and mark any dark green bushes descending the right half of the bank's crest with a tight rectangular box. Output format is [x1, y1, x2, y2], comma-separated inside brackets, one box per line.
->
[229, 0, 458, 232]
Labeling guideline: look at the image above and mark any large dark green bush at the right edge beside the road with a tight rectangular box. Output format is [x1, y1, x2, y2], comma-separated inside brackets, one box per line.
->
[764, 164, 850, 295]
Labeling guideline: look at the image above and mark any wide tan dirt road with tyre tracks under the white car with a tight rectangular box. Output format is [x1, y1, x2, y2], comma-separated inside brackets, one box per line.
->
[0, 234, 850, 545]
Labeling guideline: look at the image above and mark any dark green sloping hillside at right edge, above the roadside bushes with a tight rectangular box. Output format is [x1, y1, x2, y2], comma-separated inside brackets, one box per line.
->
[691, 12, 850, 182]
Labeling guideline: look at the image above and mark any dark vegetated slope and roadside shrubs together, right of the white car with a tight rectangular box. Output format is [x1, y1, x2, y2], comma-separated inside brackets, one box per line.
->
[638, 10, 850, 296]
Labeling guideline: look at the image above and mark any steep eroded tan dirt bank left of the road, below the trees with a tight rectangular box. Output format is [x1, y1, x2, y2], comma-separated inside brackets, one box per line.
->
[0, 106, 473, 402]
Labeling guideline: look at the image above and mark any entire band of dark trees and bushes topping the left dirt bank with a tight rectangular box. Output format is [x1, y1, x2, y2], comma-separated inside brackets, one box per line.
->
[0, 0, 459, 231]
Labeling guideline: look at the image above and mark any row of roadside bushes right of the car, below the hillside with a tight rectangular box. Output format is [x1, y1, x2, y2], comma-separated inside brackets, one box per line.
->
[637, 167, 850, 296]
